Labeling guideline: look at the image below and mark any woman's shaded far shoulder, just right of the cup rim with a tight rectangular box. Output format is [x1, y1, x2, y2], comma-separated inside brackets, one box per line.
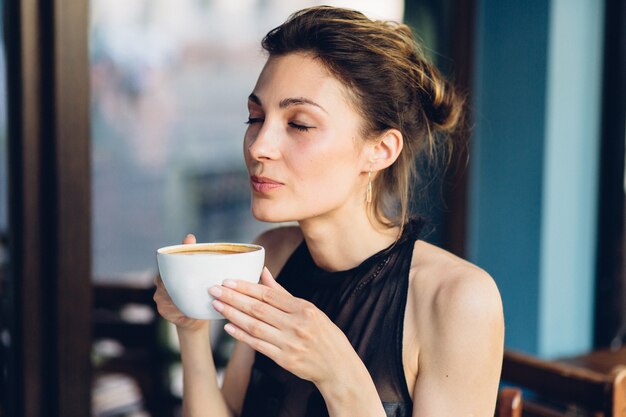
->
[254, 226, 303, 276]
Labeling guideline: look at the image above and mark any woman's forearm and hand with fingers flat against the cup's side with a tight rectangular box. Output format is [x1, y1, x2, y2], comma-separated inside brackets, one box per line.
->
[210, 269, 385, 417]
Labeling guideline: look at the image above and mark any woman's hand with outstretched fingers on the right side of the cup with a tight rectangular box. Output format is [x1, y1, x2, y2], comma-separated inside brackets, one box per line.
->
[209, 268, 362, 387]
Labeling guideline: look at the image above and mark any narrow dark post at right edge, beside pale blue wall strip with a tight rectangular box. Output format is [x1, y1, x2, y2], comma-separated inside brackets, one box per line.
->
[595, 0, 626, 347]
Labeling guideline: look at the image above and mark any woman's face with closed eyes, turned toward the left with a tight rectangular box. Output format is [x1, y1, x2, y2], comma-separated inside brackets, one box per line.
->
[244, 54, 368, 222]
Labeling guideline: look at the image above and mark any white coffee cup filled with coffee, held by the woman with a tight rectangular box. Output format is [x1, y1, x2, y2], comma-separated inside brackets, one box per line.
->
[157, 243, 265, 320]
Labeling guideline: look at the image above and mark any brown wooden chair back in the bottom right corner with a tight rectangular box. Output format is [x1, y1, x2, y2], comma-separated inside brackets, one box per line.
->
[502, 350, 626, 417]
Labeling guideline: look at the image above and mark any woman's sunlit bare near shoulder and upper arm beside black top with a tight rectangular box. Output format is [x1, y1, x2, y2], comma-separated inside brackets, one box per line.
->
[408, 245, 504, 416]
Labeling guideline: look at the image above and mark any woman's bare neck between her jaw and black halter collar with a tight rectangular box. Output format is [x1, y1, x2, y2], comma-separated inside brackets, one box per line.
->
[299, 206, 400, 271]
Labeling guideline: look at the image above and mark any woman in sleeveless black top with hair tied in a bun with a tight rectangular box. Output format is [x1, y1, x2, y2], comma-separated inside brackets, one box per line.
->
[154, 7, 503, 417]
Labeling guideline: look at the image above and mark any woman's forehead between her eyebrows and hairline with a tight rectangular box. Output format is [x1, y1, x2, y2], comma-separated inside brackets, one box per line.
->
[254, 53, 352, 111]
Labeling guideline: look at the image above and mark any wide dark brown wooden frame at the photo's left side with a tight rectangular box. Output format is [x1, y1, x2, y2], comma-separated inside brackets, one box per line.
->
[4, 0, 91, 417]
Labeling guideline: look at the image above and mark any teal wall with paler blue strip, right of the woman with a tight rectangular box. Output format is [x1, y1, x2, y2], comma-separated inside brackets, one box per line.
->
[468, 0, 603, 357]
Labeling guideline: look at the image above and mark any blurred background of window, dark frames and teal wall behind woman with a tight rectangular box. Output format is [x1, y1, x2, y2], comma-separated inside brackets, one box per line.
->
[0, 0, 626, 417]
